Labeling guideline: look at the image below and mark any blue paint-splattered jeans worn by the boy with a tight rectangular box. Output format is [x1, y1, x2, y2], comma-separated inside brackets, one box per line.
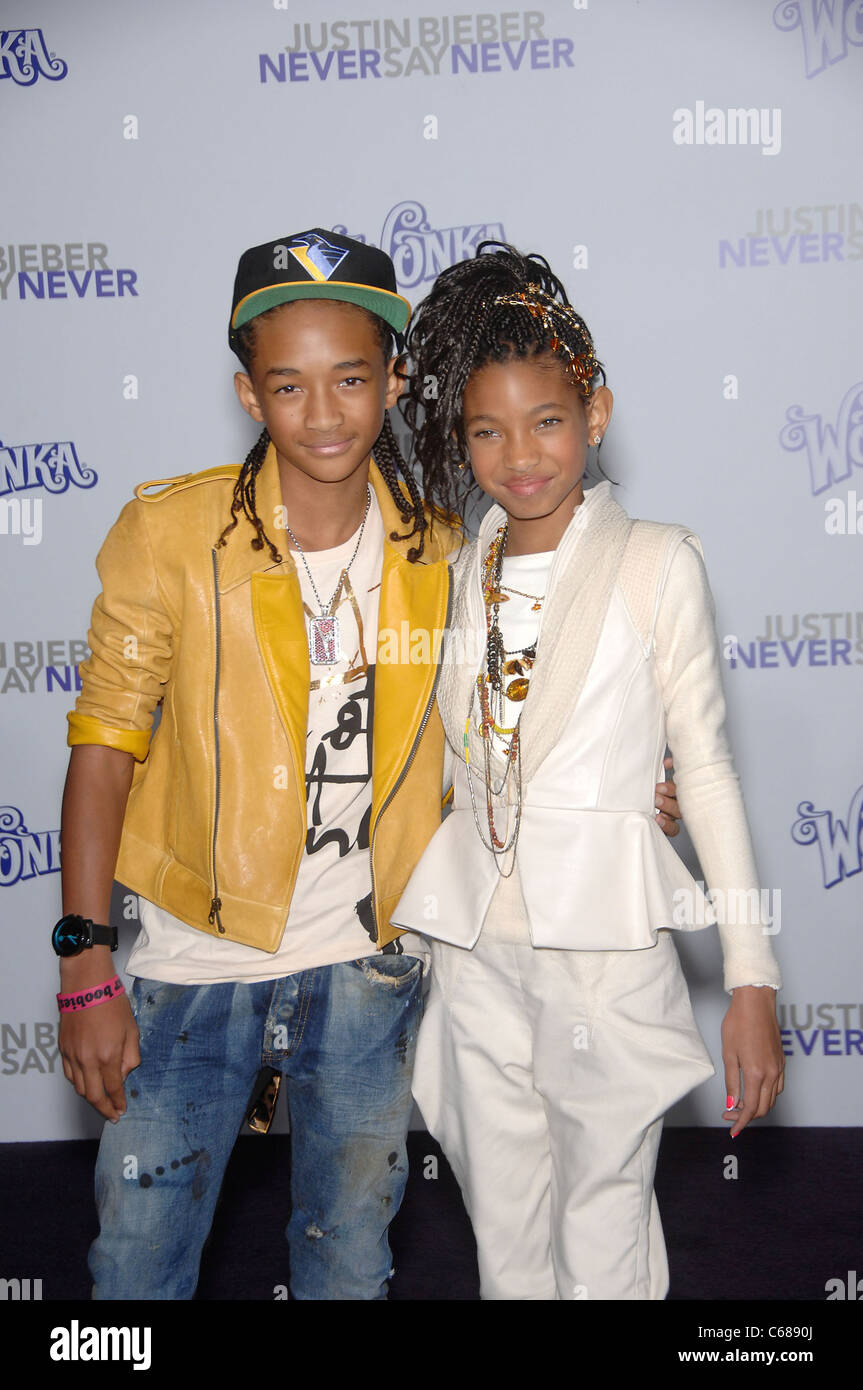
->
[90, 955, 422, 1300]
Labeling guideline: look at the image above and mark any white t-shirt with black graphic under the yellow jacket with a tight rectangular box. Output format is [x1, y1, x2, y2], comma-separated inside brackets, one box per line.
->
[126, 492, 427, 984]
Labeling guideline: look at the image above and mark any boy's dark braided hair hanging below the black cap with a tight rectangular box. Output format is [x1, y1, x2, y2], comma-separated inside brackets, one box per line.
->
[215, 304, 428, 564]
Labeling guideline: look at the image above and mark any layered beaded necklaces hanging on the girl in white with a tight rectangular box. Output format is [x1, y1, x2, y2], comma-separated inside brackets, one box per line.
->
[464, 523, 545, 861]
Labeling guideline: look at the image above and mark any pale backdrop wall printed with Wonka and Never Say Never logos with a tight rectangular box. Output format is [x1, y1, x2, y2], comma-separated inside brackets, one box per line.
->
[0, 0, 863, 1140]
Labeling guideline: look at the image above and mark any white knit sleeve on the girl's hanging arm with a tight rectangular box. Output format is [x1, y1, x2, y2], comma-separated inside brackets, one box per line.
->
[655, 537, 781, 990]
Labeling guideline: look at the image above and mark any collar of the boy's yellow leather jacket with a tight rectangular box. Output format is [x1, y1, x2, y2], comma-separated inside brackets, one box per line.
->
[215, 443, 447, 583]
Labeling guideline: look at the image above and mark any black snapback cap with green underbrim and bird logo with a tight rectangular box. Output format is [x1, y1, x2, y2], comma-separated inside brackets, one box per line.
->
[228, 227, 410, 349]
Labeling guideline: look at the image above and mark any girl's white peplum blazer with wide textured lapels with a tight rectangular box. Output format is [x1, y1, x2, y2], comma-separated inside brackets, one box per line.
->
[392, 482, 781, 990]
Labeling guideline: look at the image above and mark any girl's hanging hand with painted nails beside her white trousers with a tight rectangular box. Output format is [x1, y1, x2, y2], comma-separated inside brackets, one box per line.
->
[723, 984, 785, 1138]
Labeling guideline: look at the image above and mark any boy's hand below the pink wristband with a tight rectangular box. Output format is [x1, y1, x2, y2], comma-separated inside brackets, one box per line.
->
[58, 994, 140, 1123]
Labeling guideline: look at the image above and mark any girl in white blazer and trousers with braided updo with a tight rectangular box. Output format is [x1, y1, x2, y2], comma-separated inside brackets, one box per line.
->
[393, 243, 782, 1300]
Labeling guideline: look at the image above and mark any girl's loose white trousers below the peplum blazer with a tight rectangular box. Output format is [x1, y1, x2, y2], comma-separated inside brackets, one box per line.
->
[414, 931, 714, 1300]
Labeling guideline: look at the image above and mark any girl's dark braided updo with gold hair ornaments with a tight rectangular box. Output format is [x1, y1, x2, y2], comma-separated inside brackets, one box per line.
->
[400, 240, 606, 514]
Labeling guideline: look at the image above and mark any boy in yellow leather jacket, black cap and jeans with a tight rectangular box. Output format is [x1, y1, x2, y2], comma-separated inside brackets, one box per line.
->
[54, 228, 683, 1300]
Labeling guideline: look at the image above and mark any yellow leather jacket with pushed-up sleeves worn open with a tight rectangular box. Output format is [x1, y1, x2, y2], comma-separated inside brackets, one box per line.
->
[68, 445, 456, 951]
